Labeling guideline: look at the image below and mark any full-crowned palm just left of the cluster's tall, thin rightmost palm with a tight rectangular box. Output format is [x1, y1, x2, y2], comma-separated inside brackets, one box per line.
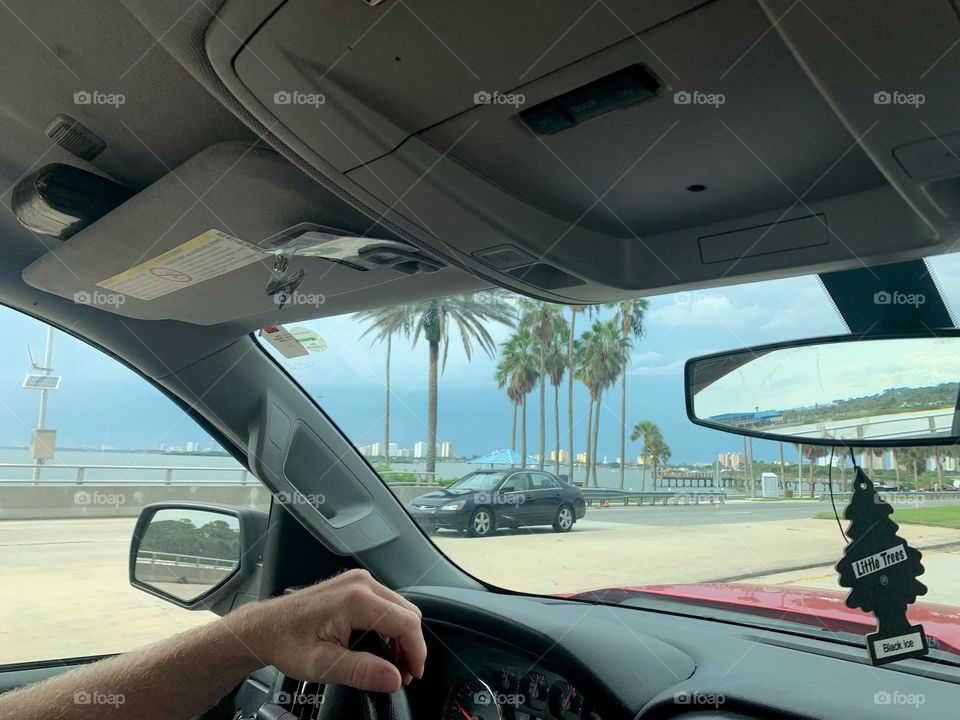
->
[576, 318, 627, 487]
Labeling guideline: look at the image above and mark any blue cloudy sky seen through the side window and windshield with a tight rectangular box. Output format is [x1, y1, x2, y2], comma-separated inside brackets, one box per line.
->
[0, 255, 960, 463]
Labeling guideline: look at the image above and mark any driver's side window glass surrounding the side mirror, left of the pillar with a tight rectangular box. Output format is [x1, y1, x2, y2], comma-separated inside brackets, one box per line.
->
[0, 307, 270, 665]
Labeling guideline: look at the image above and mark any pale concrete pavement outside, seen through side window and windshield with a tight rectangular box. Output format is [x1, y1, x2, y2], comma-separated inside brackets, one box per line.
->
[0, 501, 960, 663]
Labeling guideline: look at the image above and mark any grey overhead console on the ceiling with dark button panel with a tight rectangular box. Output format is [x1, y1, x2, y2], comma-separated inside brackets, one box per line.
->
[207, 0, 960, 302]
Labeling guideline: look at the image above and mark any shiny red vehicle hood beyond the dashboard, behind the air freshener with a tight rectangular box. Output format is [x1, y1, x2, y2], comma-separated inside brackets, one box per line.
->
[566, 583, 960, 654]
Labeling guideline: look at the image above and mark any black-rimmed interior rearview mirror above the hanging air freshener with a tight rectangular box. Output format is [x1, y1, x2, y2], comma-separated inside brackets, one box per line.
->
[685, 330, 960, 447]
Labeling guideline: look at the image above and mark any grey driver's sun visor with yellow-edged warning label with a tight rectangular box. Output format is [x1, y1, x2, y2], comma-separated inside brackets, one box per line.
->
[23, 143, 444, 325]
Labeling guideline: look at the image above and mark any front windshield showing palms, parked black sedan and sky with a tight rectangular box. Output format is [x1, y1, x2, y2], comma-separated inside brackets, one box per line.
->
[255, 256, 960, 647]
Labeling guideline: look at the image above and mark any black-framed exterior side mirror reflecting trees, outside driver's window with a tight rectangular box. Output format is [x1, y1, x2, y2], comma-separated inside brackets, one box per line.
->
[130, 502, 267, 614]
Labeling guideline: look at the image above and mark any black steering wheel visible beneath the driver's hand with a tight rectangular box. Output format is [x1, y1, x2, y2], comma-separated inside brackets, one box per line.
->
[318, 631, 413, 720]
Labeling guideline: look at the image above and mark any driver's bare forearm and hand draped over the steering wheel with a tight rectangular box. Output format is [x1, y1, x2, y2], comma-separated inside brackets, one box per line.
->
[0, 570, 427, 720]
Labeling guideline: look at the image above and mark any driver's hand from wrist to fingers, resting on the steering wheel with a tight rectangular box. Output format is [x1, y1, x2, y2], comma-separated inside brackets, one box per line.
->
[225, 570, 427, 692]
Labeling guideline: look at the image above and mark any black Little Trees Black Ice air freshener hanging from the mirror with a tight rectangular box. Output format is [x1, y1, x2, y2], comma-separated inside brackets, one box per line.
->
[836, 467, 929, 665]
